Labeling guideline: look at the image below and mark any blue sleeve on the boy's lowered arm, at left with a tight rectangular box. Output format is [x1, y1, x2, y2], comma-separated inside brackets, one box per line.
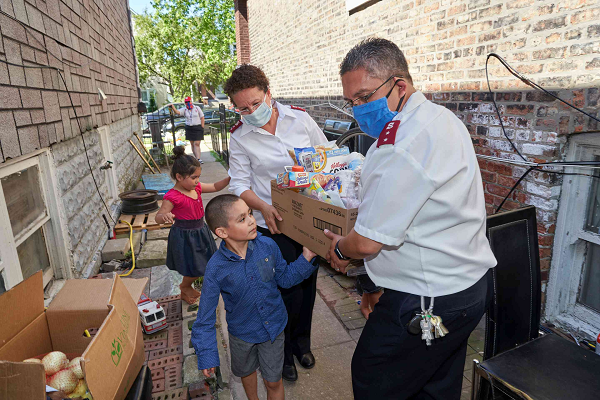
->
[192, 262, 221, 370]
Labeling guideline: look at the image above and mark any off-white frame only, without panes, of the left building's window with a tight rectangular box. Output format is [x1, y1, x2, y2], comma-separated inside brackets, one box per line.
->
[0, 149, 72, 290]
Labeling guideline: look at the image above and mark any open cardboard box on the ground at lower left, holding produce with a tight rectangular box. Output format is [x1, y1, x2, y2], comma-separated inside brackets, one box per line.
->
[0, 272, 147, 400]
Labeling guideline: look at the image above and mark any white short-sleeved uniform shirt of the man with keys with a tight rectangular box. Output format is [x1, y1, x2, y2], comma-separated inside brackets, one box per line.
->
[354, 92, 496, 296]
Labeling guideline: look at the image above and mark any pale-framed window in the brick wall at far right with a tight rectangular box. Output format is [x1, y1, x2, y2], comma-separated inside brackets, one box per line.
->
[546, 134, 600, 338]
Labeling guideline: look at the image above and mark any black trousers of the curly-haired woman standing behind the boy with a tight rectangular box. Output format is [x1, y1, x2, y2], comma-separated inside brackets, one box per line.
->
[258, 227, 317, 365]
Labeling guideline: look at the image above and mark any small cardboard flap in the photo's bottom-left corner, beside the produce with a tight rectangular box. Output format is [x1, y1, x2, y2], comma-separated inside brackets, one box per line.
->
[0, 361, 46, 400]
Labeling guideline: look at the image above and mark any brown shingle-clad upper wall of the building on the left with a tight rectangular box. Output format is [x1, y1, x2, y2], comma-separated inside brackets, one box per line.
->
[0, 0, 138, 162]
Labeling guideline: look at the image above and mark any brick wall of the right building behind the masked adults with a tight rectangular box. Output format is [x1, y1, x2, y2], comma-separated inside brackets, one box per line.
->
[239, 0, 600, 304]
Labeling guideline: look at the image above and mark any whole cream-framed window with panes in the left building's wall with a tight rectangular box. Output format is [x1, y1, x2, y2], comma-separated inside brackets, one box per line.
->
[0, 150, 70, 290]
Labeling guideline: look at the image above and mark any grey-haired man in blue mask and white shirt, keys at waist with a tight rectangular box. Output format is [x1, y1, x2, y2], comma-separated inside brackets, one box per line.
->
[326, 38, 496, 400]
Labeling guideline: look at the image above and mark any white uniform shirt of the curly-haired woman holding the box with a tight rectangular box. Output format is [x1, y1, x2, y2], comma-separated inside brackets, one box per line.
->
[229, 102, 327, 228]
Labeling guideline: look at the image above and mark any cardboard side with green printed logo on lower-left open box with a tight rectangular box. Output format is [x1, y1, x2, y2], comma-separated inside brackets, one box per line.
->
[82, 276, 145, 400]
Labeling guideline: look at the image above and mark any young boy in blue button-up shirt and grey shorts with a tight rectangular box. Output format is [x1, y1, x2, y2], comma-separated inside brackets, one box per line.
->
[192, 194, 316, 400]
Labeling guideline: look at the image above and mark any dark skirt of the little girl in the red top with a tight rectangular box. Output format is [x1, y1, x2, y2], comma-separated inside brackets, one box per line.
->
[167, 219, 217, 277]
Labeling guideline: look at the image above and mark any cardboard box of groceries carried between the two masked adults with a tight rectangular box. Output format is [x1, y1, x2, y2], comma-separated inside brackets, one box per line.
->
[271, 180, 358, 257]
